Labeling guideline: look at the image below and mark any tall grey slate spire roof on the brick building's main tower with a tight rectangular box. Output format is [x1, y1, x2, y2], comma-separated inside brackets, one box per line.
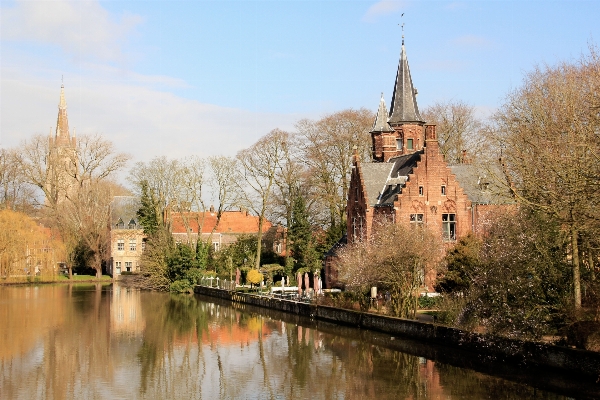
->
[388, 38, 424, 124]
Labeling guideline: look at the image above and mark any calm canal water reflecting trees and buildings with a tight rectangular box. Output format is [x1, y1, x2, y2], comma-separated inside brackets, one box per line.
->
[0, 284, 594, 400]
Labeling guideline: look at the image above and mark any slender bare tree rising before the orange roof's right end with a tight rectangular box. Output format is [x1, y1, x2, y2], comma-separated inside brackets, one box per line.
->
[237, 129, 288, 269]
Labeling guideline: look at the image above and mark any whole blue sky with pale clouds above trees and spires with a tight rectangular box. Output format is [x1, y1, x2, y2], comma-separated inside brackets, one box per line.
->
[0, 0, 600, 161]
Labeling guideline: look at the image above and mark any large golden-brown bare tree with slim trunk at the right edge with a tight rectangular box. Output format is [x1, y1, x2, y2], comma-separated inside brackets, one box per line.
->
[495, 48, 600, 308]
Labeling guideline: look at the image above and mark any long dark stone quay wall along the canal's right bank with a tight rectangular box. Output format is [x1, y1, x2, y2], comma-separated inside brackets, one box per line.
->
[194, 286, 600, 381]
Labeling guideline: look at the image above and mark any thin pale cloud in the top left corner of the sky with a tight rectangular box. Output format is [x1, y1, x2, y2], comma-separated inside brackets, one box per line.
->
[0, 0, 142, 61]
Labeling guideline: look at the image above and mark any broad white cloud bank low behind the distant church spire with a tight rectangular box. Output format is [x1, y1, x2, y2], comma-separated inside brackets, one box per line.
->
[0, 69, 308, 161]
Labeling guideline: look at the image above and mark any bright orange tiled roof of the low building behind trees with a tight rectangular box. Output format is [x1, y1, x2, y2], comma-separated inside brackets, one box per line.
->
[171, 211, 273, 234]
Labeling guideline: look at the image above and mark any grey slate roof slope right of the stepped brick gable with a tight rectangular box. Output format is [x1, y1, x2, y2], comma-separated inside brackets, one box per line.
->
[450, 164, 515, 204]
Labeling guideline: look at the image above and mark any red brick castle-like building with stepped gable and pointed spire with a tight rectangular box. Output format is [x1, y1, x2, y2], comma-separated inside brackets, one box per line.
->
[325, 41, 509, 291]
